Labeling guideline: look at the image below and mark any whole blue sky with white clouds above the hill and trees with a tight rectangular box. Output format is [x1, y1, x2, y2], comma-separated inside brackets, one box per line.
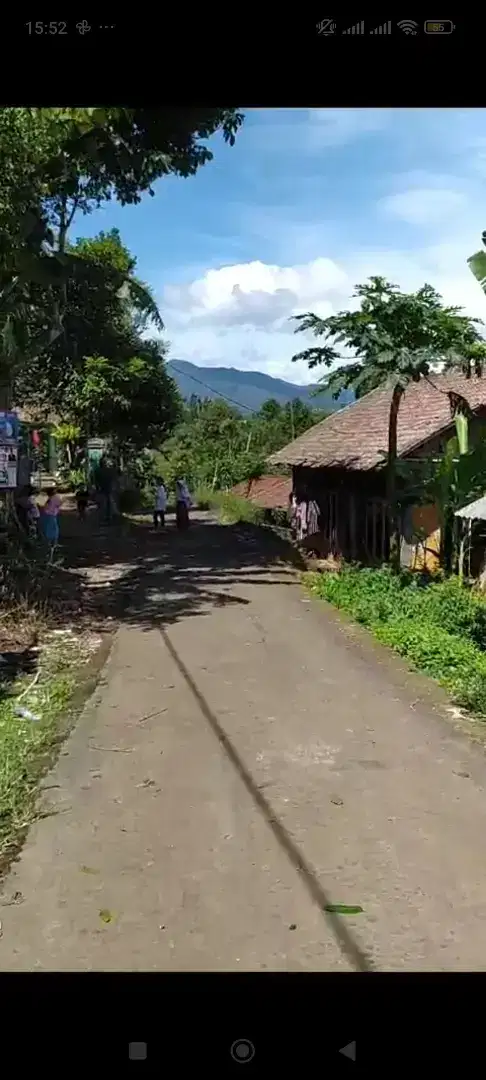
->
[72, 109, 486, 382]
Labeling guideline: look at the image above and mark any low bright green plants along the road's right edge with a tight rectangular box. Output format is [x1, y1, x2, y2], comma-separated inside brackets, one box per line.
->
[306, 567, 486, 718]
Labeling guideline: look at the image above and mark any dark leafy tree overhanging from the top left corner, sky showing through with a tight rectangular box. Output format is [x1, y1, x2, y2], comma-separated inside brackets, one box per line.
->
[0, 108, 243, 404]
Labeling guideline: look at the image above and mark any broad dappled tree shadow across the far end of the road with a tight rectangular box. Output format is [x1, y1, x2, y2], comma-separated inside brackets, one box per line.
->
[56, 511, 303, 629]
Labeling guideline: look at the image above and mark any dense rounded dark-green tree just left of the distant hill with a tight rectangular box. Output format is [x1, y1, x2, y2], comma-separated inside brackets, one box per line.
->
[16, 229, 179, 456]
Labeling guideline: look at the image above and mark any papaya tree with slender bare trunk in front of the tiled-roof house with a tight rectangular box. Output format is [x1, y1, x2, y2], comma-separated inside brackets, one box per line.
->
[293, 276, 486, 567]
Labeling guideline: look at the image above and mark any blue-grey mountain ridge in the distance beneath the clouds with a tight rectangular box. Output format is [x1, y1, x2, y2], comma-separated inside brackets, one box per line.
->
[167, 360, 353, 413]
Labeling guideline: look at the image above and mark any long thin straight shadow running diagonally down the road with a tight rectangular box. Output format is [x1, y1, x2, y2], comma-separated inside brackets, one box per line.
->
[159, 626, 373, 972]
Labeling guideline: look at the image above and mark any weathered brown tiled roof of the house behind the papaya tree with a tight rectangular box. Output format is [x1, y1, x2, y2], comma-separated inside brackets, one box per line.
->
[268, 374, 486, 470]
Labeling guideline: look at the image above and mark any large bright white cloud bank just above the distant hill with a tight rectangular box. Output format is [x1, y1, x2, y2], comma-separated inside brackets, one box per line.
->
[162, 237, 486, 382]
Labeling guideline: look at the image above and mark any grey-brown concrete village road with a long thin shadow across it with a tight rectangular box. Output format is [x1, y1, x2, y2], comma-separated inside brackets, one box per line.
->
[0, 521, 486, 971]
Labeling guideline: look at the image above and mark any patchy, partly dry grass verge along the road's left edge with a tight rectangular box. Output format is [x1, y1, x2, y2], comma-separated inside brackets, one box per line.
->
[0, 632, 108, 874]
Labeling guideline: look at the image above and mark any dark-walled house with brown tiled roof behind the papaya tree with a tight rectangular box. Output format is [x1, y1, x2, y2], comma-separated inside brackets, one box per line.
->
[269, 373, 486, 569]
